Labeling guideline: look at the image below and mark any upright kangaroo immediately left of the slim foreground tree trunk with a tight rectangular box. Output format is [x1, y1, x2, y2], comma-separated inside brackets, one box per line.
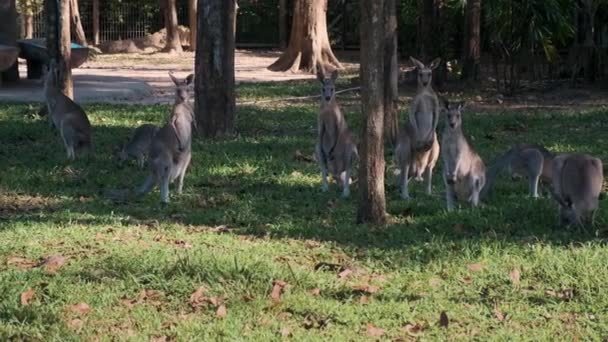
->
[315, 66, 358, 198]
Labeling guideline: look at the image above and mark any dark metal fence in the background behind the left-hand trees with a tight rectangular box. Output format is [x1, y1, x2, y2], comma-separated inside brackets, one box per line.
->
[20, 0, 359, 47]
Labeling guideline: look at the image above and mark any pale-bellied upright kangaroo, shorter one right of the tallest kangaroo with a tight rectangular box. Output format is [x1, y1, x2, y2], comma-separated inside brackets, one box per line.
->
[441, 100, 486, 211]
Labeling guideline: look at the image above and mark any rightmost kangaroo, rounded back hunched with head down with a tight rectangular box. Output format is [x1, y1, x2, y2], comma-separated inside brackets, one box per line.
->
[551, 154, 604, 225]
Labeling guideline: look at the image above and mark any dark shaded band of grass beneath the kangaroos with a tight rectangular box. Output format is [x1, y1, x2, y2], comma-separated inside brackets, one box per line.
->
[0, 101, 608, 264]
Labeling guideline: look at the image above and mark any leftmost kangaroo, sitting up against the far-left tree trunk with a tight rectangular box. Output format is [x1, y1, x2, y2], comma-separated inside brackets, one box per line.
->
[44, 62, 92, 160]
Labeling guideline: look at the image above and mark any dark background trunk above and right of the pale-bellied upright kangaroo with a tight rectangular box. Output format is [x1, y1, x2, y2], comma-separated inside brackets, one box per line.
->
[462, 0, 481, 80]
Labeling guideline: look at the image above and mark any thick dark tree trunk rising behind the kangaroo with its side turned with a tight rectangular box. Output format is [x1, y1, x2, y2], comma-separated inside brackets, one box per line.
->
[195, 0, 236, 137]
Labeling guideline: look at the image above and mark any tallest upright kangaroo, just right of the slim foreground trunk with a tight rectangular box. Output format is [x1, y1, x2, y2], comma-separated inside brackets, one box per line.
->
[395, 57, 441, 199]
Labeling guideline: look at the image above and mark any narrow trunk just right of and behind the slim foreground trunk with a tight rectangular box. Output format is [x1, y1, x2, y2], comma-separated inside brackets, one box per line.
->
[384, 0, 399, 145]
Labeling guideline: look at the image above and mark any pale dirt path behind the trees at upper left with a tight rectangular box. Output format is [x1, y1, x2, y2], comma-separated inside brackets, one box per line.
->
[0, 50, 358, 104]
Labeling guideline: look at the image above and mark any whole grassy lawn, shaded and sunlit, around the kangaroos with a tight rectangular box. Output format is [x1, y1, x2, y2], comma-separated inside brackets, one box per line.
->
[0, 82, 608, 341]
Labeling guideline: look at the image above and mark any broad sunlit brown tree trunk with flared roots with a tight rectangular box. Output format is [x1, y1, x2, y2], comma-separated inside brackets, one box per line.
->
[268, 0, 342, 74]
